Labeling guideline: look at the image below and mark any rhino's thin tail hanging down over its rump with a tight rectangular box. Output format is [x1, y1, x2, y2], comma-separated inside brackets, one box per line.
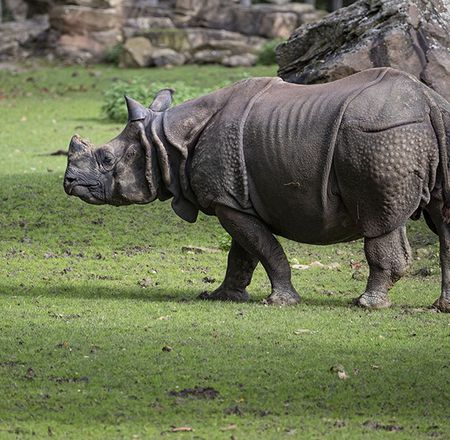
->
[430, 104, 450, 224]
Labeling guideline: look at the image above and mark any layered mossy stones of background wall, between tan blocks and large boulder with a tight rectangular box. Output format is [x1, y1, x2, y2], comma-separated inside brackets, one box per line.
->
[121, 0, 325, 67]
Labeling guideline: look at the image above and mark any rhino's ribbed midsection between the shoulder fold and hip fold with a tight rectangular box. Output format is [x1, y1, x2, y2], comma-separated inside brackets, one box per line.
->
[243, 79, 362, 244]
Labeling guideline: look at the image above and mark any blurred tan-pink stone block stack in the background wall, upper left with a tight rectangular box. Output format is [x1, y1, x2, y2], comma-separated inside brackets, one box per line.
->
[50, 0, 122, 62]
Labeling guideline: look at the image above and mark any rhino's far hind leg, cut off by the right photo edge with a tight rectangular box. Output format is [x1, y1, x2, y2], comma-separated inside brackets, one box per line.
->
[427, 201, 450, 313]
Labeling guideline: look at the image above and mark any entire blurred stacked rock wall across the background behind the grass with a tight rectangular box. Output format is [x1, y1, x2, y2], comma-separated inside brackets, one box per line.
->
[0, 0, 326, 67]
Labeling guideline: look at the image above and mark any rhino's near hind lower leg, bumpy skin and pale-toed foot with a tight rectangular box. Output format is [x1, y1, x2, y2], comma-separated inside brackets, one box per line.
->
[355, 226, 411, 309]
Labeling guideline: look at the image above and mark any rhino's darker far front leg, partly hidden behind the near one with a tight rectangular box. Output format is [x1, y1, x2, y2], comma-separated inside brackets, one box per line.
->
[200, 239, 258, 301]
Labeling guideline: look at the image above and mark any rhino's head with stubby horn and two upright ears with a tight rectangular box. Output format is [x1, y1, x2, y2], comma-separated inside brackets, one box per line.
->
[64, 89, 172, 205]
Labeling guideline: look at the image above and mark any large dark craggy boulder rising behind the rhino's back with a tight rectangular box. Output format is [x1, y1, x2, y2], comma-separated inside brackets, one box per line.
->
[276, 0, 450, 100]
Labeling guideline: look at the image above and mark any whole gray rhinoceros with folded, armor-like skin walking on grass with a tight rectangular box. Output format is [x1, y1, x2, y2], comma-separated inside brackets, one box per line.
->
[64, 68, 450, 312]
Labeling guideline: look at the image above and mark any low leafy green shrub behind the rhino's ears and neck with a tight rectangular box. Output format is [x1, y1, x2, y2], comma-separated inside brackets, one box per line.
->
[102, 80, 218, 122]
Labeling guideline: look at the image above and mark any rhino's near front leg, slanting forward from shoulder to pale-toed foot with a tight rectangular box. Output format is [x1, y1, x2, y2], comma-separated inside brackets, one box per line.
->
[216, 206, 300, 305]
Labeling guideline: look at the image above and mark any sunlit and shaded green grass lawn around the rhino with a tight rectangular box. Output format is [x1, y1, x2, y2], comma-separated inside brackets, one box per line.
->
[0, 66, 450, 440]
